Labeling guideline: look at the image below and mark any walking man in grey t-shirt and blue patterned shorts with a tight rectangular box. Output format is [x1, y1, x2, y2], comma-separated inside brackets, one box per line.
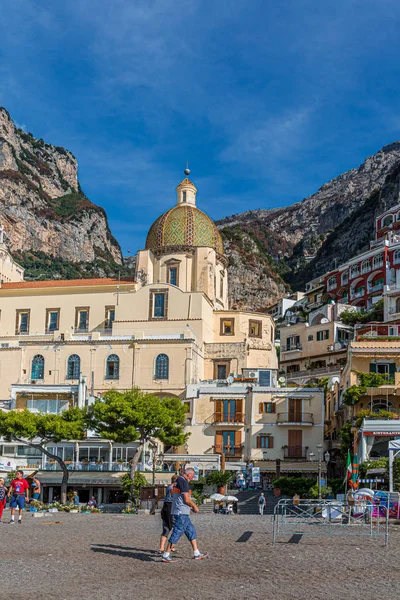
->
[162, 467, 208, 562]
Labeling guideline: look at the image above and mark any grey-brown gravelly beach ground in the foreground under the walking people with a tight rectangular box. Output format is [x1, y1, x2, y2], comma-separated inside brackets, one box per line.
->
[0, 511, 400, 600]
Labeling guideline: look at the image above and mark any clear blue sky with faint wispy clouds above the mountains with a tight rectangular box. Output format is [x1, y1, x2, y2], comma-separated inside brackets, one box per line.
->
[0, 0, 400, 254]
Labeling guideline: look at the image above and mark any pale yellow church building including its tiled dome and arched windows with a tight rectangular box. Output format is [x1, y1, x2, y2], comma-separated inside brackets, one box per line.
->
[0, 173, 277, 406]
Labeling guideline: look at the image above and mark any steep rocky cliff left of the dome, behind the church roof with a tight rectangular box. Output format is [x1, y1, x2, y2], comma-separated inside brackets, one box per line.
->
[0, 108, 122, 276]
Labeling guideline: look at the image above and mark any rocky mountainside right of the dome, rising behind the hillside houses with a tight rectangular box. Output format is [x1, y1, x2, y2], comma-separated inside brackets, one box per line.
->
[218, 142, 400, 308]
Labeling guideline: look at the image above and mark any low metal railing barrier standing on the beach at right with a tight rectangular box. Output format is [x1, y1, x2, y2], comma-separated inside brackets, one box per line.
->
[273, 499, 389, 546]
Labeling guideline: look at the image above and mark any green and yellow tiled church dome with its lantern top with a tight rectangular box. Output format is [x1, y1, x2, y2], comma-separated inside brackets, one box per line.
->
[146, 179, 224, 254]
